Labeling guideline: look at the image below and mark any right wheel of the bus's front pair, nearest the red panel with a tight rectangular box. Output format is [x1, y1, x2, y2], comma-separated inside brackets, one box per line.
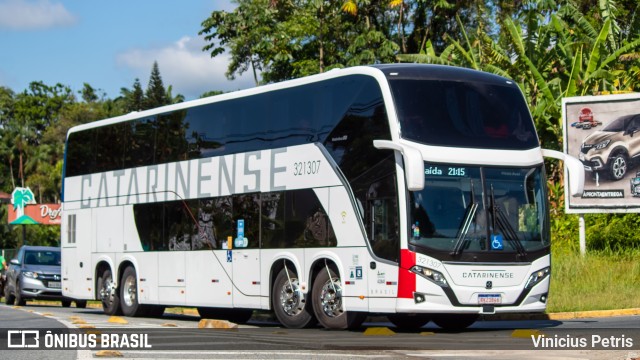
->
[312, 267, 367, 329]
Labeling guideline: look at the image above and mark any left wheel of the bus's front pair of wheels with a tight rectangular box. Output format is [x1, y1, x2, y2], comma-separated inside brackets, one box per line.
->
[271, 269, 316, 329]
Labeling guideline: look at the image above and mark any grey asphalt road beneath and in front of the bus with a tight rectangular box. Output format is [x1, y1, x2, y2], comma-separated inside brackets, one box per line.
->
[0, 305, 640, 360]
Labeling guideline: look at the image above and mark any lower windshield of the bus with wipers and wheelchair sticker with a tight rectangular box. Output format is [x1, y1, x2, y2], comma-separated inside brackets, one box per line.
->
[409, 164, 550, 256]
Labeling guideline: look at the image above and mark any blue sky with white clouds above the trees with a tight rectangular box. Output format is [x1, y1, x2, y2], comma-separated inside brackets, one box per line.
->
[0, 0, 254, 100]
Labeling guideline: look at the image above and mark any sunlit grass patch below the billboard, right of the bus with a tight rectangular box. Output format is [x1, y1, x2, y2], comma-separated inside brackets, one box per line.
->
[547, 251, 640, 313]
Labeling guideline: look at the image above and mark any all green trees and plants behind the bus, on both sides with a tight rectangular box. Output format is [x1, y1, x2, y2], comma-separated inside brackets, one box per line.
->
[0, 0, 640, 250]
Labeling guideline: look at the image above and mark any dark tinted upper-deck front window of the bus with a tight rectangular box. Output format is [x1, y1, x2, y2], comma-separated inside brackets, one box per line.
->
[389, 79, 539, 150]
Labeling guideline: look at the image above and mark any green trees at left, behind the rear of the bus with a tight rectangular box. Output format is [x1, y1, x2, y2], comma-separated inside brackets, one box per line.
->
[0, 63, 183, 248]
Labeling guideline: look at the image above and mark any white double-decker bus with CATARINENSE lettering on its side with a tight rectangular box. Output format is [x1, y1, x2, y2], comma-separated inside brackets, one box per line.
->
[61, 64, 583, 328]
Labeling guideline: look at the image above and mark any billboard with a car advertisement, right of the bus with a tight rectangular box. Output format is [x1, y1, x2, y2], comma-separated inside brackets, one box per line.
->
[562, 94, 640, 213]
